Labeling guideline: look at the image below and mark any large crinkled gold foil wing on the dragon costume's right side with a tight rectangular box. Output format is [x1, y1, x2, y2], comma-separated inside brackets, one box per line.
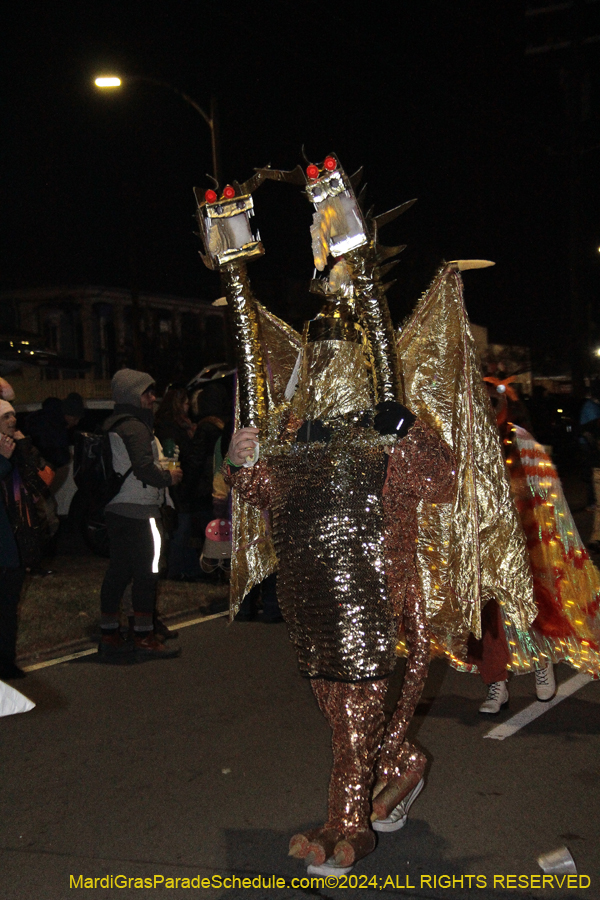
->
[398, 266, 536, 652]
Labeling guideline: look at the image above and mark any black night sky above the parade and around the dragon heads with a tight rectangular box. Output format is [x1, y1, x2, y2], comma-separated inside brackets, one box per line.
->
[0, 0, 600, 362]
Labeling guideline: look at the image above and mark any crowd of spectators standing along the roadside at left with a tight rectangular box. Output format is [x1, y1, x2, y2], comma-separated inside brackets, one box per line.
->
[0, 369, 281, 680]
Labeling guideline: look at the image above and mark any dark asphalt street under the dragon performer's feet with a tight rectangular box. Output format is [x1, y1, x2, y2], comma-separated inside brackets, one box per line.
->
[0, 618, 600, 900]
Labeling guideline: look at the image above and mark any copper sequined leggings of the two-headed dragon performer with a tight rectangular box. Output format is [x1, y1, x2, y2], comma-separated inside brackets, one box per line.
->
[311, 604, 429, 834]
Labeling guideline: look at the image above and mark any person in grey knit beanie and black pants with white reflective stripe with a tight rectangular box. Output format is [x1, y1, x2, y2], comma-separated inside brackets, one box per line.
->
[98, 369, 182, 662]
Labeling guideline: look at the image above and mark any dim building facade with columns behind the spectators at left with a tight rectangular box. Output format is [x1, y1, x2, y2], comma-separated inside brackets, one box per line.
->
[0, 286, 231, 400]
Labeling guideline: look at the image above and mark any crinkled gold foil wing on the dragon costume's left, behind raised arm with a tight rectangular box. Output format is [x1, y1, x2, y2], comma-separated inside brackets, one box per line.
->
[229, 303, 302, 621]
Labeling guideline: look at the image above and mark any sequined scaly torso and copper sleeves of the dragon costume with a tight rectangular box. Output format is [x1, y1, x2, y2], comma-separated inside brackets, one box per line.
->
[233, 418, 453, 681]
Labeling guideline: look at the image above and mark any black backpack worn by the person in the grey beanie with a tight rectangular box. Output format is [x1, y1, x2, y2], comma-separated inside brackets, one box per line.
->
[73, 416, 134, 507]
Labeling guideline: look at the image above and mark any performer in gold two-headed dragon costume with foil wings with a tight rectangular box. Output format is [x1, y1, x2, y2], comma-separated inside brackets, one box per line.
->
[196, 155, 533, 874]
